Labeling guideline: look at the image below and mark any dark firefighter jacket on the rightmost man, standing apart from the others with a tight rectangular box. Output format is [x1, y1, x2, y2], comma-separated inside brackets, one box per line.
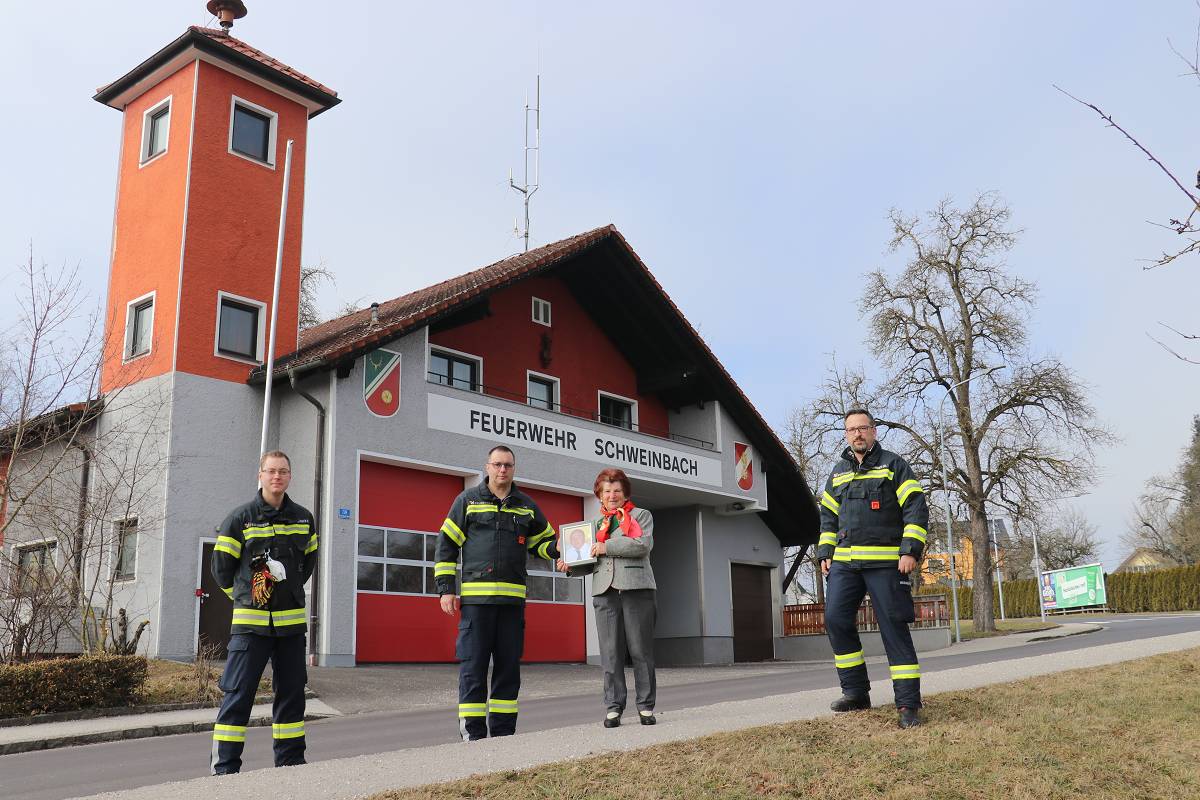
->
[817, 443, 929, 567]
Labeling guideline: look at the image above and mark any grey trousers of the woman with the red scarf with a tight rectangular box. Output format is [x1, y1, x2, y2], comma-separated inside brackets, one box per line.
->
[592, 589, 658, 712]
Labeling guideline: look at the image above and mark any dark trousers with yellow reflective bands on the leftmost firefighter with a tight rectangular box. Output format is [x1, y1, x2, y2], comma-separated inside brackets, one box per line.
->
[209, 633, 307, 775]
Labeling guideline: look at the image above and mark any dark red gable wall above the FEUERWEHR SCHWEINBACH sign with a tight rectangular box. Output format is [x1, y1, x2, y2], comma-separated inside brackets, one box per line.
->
[430, 275, 667, 435]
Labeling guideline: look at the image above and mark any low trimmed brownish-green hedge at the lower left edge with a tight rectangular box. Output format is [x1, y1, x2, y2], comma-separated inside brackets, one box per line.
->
[0, 655, 149, 717]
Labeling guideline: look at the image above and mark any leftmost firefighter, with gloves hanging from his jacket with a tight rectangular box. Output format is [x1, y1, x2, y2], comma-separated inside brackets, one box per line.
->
[211, 450, 317, 775]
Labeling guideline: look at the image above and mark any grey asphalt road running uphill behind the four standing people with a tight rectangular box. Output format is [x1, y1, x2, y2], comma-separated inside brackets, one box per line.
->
[0, 614, 1200, 800]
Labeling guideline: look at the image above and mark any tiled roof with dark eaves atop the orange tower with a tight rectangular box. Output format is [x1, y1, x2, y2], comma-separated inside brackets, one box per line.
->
[92, 30, 342, 119]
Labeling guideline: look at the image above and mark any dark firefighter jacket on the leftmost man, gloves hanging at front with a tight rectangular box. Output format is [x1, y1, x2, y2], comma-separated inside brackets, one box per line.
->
[212, 489, 317, 636]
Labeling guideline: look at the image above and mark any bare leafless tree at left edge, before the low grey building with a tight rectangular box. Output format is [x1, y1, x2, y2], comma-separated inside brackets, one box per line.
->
[0, 253, 164, 661]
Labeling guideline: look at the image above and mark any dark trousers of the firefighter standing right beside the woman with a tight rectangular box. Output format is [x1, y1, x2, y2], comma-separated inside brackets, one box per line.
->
[455, 603, 524, 740]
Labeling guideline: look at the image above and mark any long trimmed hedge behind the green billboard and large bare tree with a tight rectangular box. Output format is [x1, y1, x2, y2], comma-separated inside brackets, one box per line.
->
[917, 565, 1200, 619]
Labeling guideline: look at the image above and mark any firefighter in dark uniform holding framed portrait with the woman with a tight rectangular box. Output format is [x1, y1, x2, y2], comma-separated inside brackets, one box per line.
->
[433, 445, 558, 741]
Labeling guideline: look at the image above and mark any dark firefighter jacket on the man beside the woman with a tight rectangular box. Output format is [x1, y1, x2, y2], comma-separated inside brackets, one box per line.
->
[433, 479, 558, 604]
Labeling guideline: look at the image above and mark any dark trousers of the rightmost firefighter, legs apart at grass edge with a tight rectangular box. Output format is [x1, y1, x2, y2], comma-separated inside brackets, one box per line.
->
[826, 561, 920, 709]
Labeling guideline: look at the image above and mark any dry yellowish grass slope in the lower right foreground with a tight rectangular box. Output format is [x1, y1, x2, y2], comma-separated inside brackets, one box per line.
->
[373, 649, 1200, 800]
